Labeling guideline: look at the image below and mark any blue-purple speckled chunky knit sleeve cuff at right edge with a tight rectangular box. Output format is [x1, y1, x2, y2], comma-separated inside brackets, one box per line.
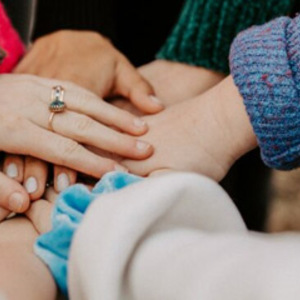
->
[230, 16, 300, 170]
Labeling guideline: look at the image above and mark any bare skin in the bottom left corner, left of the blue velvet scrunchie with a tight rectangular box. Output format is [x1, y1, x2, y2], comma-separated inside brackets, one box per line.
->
[0, 217, 57, 300]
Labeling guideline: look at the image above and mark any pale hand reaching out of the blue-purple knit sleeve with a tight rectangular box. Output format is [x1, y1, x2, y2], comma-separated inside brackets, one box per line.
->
[123, 77, 257, 181]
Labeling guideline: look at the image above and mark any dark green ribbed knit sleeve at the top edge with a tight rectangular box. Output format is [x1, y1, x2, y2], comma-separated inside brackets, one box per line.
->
[157, 0, 295, 74]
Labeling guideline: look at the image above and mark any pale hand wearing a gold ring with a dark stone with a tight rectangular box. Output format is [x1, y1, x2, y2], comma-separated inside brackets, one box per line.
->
[0, 75, 152, 199]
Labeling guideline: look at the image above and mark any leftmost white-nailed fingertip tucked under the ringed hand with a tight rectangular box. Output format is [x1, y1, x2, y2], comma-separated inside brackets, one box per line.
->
[3, 154, 24, 183]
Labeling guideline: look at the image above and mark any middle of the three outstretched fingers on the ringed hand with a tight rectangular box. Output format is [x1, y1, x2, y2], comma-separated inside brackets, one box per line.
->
[30, 102, 153, 159]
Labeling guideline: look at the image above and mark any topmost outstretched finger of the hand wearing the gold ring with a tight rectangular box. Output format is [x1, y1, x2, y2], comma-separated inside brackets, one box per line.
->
[36, 81, 148, 135]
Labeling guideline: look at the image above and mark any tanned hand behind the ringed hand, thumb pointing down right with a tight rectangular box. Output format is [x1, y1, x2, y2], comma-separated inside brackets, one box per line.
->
[15, 30, 163, 113]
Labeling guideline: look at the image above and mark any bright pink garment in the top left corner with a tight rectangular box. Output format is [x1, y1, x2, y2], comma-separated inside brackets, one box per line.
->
[0, 2, 25, 73]
